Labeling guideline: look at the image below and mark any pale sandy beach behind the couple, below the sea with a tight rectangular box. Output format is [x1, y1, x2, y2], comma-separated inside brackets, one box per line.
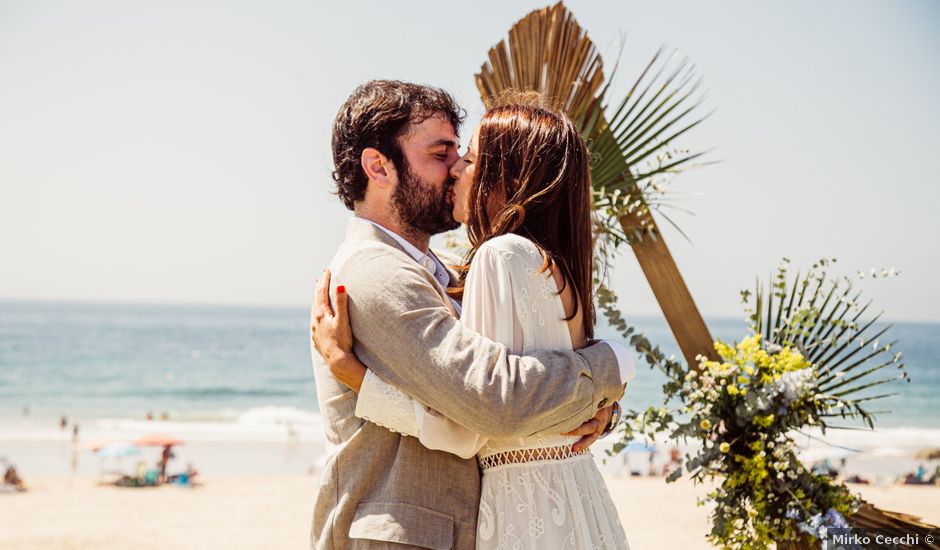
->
[0, 430, 940, 550]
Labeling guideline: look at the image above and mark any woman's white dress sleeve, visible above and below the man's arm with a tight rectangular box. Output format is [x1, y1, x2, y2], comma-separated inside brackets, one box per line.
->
[356, 245, 518, 458]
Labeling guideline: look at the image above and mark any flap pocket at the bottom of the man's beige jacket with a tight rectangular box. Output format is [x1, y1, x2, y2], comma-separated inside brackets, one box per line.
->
[349, 502, 454, 550]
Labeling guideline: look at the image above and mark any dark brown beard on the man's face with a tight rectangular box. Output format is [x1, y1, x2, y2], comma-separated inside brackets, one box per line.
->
[392, 163, 460, 235]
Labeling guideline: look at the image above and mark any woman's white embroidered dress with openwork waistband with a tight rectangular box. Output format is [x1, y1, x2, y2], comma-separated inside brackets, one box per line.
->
[356, 235, 629, 550]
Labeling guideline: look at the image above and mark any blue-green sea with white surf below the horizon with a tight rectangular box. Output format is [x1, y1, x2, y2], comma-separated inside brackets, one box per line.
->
[0, 302, 940, 439]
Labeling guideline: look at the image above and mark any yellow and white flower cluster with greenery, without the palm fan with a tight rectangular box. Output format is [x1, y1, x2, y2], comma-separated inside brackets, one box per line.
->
[672, 334, 860, 548]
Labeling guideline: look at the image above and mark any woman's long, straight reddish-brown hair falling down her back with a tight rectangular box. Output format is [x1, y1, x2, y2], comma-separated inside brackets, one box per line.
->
[452, 103, 595, 338]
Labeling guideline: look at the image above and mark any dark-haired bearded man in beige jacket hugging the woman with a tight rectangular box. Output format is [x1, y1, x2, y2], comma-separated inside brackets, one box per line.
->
[311, 80, 632, 550]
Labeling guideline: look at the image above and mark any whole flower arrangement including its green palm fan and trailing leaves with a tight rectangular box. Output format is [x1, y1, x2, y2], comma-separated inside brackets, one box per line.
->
[614, 259, 907, 549]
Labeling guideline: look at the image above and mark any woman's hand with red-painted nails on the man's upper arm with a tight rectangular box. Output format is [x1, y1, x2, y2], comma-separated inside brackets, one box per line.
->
[310, 270, 366, 392]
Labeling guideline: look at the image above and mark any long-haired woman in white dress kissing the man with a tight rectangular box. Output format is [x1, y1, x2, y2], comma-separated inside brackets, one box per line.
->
[316, 104, 628, 550]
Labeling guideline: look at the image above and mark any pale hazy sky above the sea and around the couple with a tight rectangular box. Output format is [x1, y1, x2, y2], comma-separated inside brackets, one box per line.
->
[0, 0, 940, 320]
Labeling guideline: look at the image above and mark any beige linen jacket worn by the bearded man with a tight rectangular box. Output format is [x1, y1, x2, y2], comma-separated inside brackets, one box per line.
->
[311, 218, 622, 550]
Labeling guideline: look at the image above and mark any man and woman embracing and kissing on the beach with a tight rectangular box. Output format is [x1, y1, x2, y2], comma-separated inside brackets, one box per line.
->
[311, 80, 635, 550]
